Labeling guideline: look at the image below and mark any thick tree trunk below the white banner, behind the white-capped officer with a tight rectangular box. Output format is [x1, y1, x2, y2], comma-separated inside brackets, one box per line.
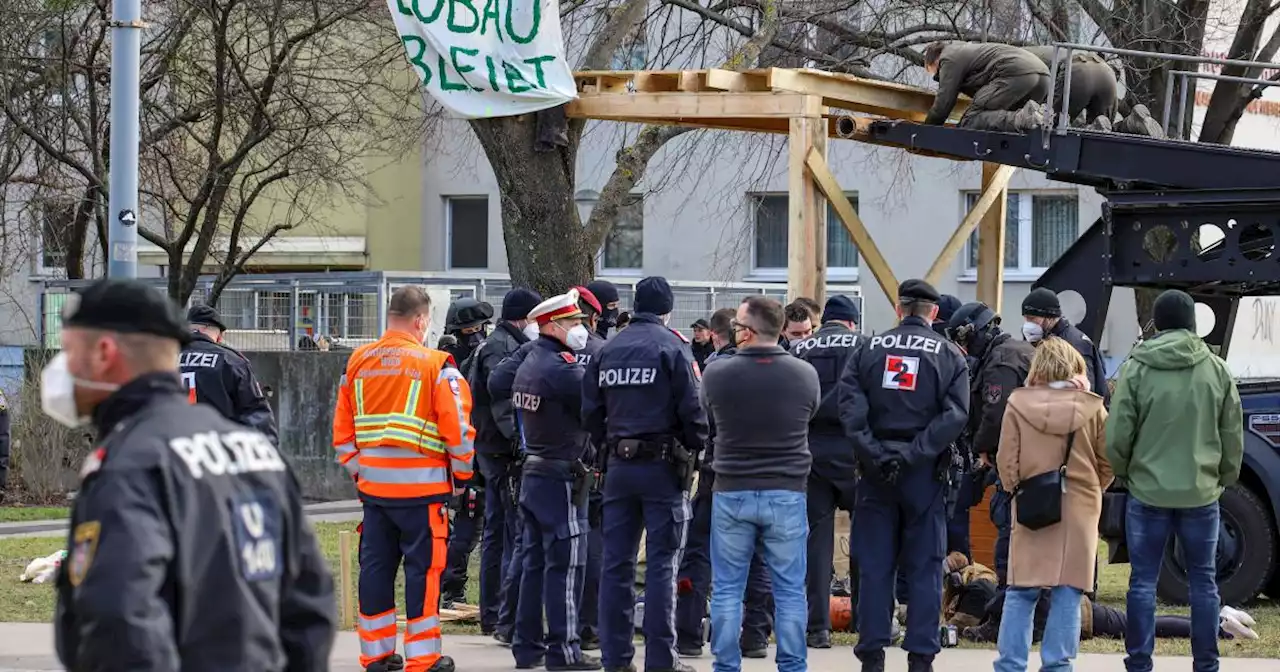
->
[471, 114, 595, 296]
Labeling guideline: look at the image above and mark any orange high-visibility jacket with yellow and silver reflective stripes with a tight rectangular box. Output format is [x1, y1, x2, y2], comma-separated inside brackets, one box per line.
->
[333, 332, 475, 499]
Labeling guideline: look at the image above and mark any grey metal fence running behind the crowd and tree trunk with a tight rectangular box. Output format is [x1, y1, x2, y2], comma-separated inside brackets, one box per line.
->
[40, 271, 863, 351]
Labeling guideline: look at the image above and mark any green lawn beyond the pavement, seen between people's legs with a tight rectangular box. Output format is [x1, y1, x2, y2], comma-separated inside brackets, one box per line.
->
[0, 522, 1280, 658]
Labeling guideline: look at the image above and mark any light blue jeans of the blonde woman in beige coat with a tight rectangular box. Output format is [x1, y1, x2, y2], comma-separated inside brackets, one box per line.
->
[996, 586, 1083, 672]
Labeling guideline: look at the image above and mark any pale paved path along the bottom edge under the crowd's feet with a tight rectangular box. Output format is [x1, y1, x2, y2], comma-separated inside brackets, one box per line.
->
[0, 623, 1277, 672]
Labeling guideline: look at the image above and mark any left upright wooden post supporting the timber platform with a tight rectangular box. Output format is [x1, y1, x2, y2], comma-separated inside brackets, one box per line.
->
[787, 101, 827, 305]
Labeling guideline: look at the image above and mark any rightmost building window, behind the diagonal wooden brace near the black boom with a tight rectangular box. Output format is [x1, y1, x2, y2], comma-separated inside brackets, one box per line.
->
[961, 192, 1080, 273]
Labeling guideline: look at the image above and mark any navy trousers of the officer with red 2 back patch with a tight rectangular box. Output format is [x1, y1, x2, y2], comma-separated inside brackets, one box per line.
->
[854, 465, 946, 660]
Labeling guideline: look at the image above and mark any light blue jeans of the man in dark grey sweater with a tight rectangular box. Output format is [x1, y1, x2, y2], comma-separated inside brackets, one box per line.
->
[712, 490, 809, 672]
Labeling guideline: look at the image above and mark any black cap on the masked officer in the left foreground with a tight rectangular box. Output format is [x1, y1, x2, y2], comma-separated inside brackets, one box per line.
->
[63, 278, 191, 344]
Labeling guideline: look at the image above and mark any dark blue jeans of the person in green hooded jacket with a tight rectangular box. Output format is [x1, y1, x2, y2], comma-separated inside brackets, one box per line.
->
[1124, 495, 1221, 672]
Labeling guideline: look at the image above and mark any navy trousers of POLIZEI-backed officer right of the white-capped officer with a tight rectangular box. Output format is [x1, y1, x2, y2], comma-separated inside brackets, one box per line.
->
[600, 460, 691, 669]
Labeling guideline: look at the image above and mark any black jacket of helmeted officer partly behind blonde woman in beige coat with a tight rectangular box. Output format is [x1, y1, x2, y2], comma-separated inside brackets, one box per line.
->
[969, 333, 1036, 456]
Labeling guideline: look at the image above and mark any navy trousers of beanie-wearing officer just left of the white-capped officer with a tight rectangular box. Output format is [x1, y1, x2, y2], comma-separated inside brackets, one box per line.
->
[476, 452, 520, 632]
